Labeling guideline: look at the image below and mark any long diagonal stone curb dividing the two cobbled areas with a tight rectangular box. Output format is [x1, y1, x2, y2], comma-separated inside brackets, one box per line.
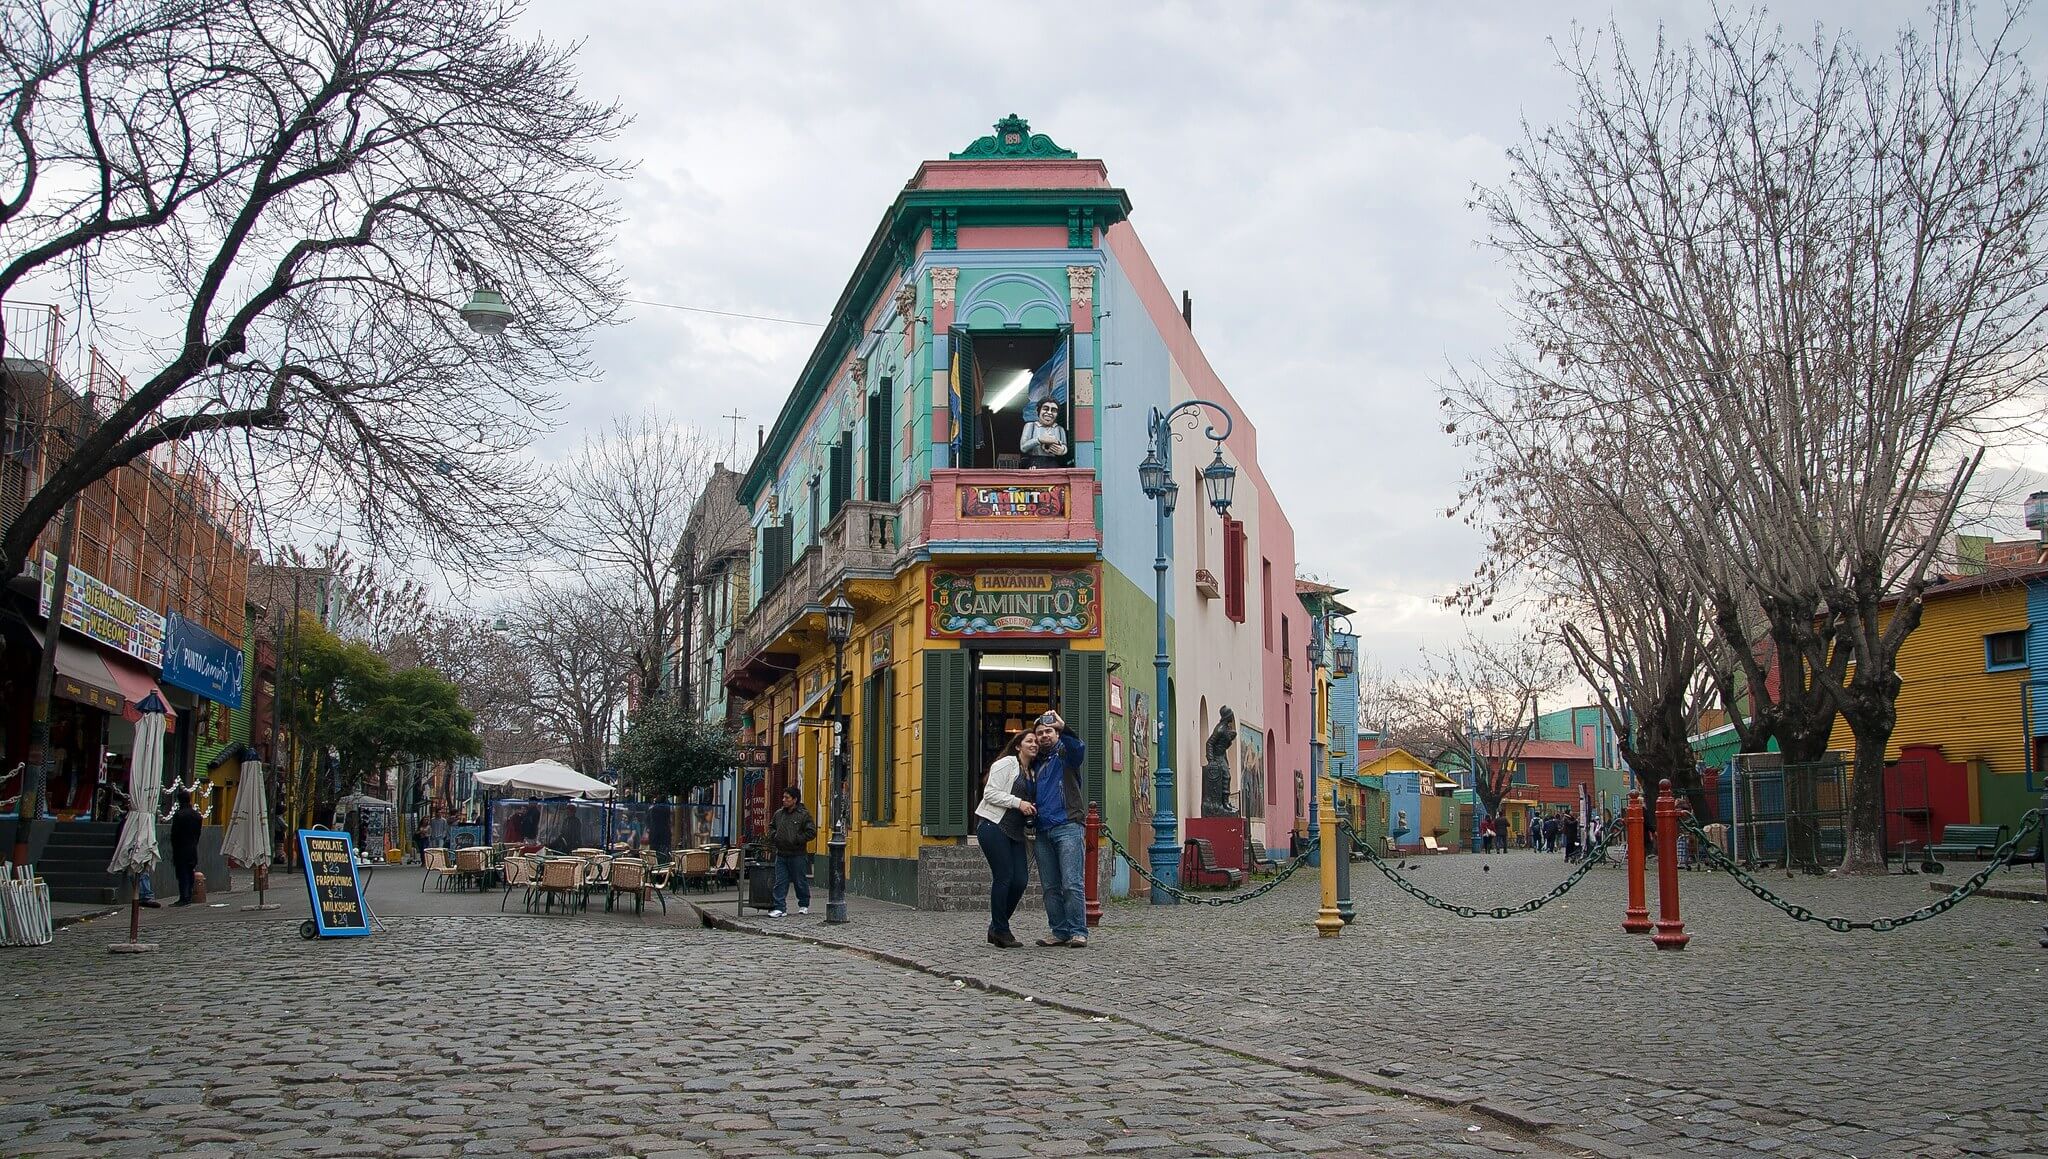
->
[690, 901, 1597, 1159]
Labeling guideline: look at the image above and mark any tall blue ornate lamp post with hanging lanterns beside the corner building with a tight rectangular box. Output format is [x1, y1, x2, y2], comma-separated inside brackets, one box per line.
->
[1139, 399, 1237, 905]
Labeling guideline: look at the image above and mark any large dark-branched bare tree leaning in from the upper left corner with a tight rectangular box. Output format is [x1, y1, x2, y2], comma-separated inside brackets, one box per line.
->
[0, 0, 625, 575]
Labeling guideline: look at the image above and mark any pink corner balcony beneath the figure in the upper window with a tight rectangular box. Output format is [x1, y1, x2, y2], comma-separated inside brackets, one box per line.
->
[903, 469, 1102, 555]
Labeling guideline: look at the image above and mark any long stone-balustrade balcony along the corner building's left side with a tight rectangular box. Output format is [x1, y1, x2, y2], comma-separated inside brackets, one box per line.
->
[725, 500, 903, 688]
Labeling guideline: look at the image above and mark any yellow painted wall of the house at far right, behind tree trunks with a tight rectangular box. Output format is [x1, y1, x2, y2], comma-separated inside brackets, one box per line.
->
[1829, 586, 2028, 772]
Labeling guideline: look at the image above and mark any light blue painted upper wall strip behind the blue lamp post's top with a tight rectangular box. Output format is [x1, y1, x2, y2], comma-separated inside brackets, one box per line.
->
[1096, 256, 1192, 597]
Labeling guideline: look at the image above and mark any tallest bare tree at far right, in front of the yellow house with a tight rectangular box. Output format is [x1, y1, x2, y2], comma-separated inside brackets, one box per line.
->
[1479, 4, 2048, 870]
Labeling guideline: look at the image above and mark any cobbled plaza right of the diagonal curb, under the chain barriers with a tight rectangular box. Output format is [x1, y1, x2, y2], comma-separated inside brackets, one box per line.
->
[708, 852, 2048, 1157]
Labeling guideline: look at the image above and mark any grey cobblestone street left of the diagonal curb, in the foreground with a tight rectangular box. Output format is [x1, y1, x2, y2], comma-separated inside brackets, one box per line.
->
[0, 896, 1571, 1159]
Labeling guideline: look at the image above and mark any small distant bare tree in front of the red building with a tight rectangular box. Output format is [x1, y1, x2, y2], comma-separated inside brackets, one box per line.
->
[1389, 635, 1565, 815]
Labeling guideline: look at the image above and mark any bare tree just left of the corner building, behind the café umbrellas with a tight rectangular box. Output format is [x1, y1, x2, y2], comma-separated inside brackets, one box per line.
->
[553, 416, 719, 704]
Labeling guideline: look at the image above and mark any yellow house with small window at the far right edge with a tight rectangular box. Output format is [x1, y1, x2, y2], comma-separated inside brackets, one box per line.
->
[1829, 567, 2048, 838]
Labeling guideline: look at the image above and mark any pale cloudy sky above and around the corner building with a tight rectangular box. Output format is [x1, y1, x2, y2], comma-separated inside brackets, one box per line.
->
[507, 0, 2015, 670]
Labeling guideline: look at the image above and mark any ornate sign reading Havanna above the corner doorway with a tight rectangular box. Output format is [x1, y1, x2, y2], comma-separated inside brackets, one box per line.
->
[926, 567, 1102, 639]
